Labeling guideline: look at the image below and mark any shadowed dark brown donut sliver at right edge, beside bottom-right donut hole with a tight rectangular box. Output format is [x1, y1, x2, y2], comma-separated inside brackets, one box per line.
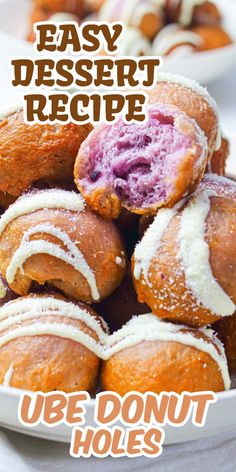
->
[214, 313, 236, 374]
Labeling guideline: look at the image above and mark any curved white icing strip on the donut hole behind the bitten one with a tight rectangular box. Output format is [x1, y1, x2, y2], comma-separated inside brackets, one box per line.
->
[157, 72, 222, 151]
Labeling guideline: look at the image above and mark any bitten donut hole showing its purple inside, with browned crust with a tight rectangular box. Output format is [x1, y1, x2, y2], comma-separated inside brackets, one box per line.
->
[74, 104, 208, 219]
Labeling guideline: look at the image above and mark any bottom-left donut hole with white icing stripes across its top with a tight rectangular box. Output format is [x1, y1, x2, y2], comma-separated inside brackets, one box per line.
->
[0, 294, 106, 393]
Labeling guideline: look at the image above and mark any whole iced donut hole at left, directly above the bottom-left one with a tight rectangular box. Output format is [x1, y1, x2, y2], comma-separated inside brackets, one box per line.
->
[0, 189, 126, 303]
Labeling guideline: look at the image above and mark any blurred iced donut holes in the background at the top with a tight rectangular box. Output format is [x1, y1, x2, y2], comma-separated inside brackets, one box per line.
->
[28, 0, 232, 58]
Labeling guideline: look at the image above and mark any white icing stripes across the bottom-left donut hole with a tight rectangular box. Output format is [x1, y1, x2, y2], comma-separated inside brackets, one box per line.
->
[0, 296, 107, 358]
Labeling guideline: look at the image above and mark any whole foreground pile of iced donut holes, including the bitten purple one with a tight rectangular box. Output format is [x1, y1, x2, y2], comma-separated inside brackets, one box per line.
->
[0, 73, 236, 395]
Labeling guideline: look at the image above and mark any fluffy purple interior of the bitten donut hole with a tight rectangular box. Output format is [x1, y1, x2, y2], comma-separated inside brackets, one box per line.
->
[80, 105, 200, 208]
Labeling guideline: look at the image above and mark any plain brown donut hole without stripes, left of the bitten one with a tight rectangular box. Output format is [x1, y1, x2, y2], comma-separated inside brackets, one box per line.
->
[0, 111, 92, 196]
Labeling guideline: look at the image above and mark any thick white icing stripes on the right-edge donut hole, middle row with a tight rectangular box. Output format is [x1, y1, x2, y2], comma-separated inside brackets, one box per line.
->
[134, 174, 236, 317]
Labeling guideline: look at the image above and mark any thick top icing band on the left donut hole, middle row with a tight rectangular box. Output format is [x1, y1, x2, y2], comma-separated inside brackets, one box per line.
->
[0, 189, 85, 234]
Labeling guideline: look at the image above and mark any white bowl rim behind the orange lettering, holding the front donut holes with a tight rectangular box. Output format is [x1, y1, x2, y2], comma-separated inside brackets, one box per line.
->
[0, 387, 236, 445]
